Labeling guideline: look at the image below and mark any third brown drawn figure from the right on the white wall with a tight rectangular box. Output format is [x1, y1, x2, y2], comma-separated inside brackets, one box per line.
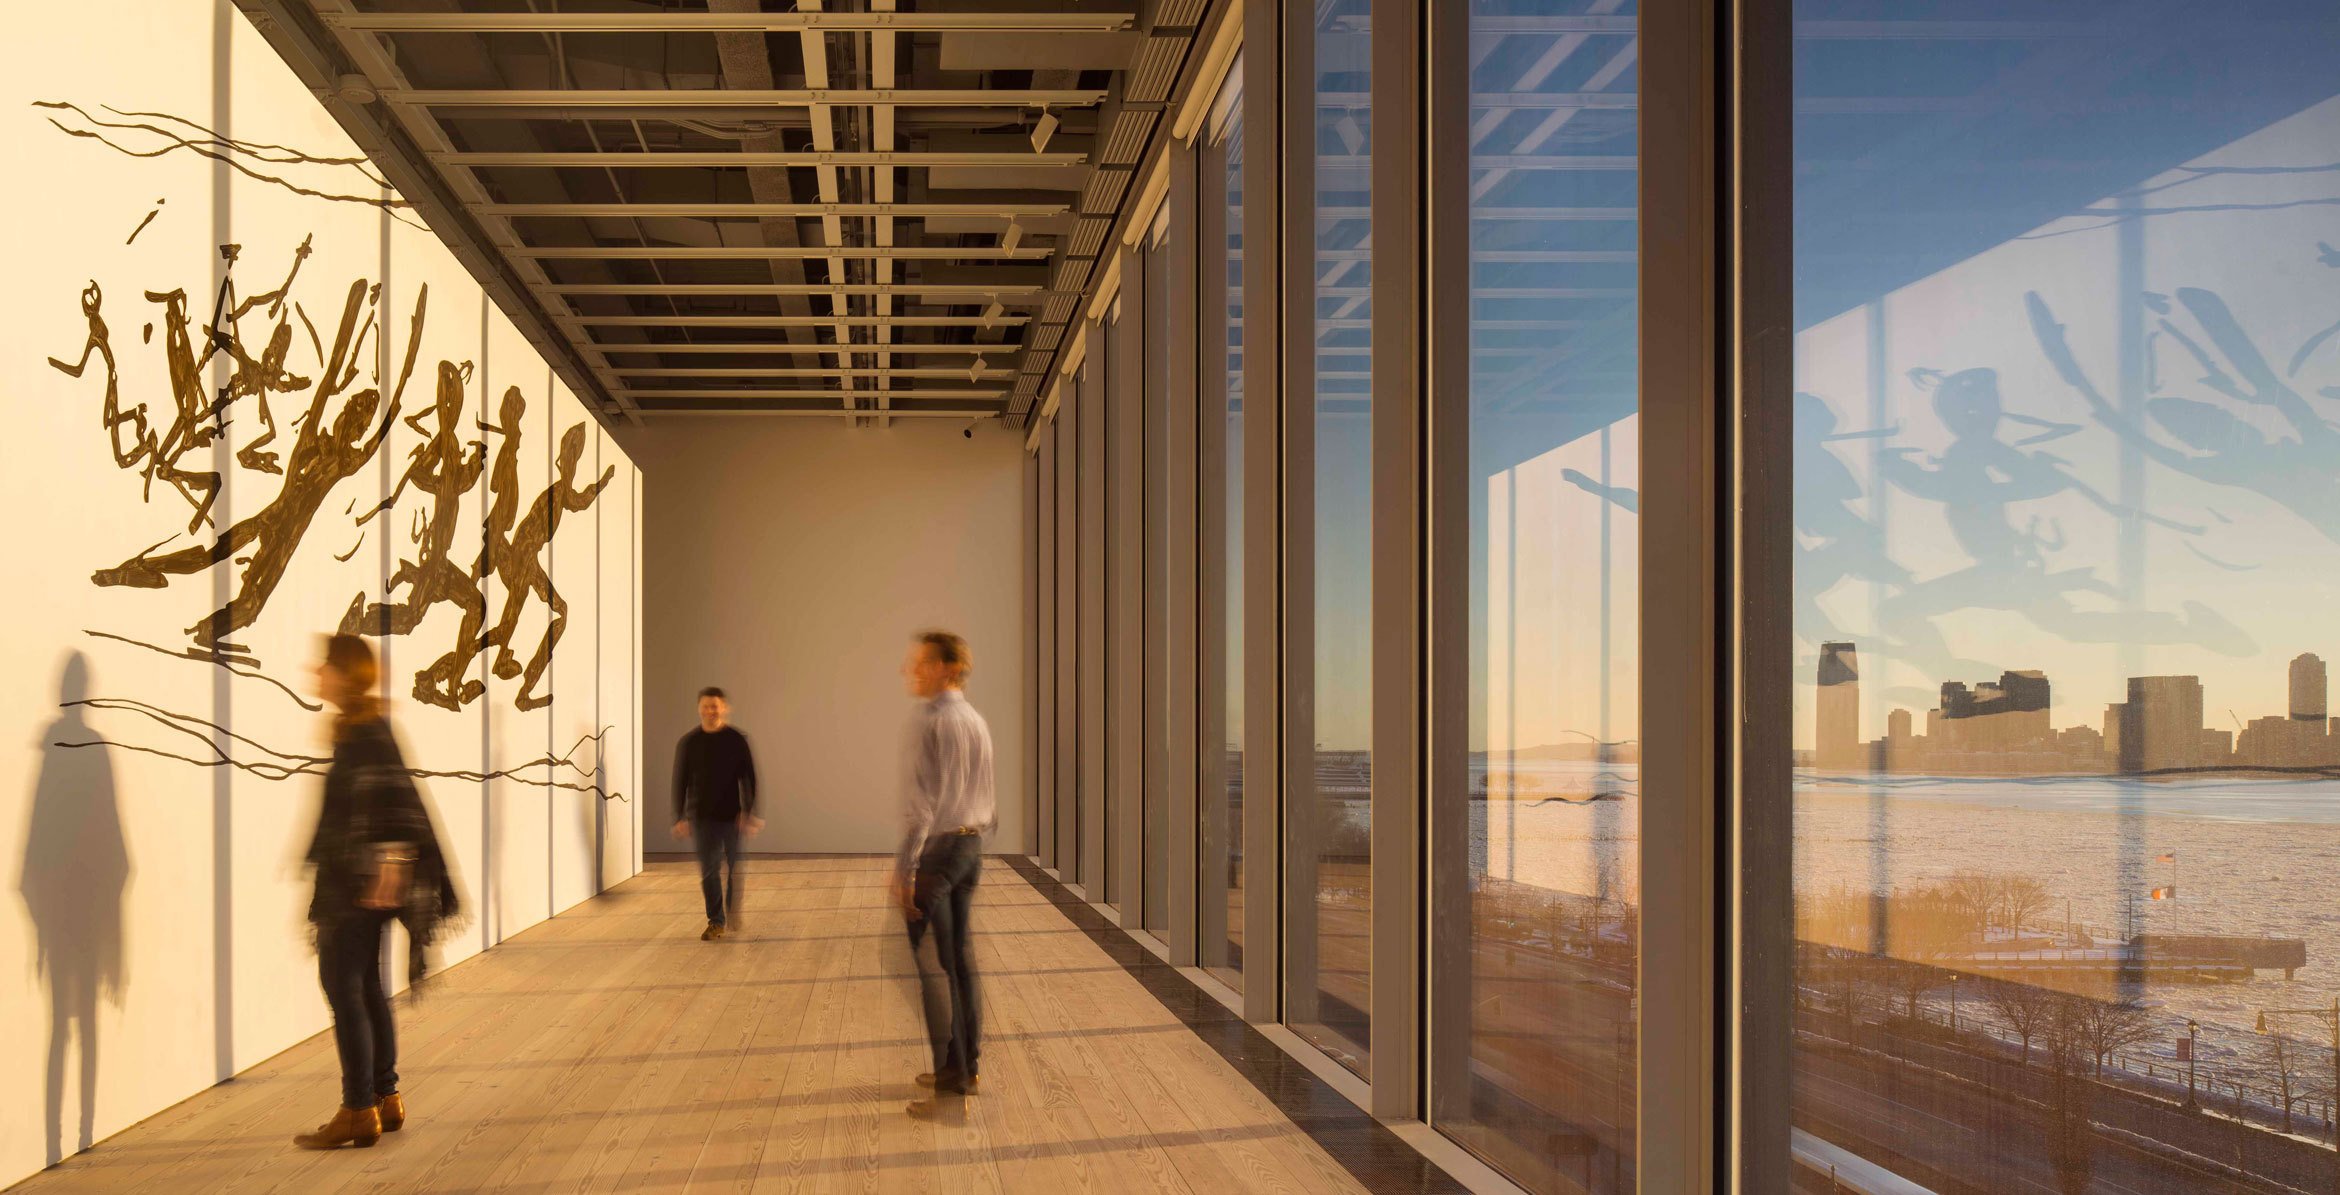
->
[342, 360, 487, 709]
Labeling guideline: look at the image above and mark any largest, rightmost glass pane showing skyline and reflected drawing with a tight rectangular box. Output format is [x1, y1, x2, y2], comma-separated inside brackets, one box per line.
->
[1792, 0, 2340, 1190]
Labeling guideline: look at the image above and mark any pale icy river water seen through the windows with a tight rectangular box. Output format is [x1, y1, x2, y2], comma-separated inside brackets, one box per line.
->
[1472, 762, 2340, 1075]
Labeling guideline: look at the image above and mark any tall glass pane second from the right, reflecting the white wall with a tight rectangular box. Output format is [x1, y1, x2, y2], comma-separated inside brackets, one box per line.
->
[1432, 0, 1640, 1193]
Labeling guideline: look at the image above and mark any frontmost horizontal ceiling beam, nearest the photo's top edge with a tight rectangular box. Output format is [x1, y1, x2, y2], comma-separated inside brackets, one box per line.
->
[318, 12, 1133, 33]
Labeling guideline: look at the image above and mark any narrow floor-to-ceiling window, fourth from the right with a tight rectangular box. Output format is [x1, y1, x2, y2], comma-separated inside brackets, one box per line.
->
[1196, 63, 1245, 987]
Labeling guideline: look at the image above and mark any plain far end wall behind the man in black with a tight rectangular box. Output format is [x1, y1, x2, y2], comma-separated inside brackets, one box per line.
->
[620, 416, 1030, 854]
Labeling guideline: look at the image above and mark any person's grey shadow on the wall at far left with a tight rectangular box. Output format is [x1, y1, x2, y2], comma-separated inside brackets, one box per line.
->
[19, 652, 131, 1165]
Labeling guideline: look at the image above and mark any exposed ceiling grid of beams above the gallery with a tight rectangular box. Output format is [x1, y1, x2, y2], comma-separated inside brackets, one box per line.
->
[267, 0, 1203, 423]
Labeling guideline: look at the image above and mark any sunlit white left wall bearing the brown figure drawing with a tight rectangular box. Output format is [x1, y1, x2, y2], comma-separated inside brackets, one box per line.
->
[0, 0, 644, 1183]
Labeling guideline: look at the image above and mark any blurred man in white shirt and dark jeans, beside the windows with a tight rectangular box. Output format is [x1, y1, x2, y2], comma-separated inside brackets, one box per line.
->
[894, 631, 999, 1120]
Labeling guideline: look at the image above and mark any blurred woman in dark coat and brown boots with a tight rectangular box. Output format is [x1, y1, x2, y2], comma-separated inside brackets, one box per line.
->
[293, 634, 456, 1148]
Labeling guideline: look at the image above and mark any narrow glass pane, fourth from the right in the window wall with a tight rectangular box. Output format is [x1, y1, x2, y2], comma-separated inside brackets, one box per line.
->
[1198, 63, 1243, 987]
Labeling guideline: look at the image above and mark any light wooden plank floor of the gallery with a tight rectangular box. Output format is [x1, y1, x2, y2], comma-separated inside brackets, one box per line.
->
[14, 858, 1362, 1195]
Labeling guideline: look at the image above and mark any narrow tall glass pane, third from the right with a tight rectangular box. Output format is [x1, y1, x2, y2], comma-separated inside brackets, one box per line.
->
[1287, 0, 1374, 1073]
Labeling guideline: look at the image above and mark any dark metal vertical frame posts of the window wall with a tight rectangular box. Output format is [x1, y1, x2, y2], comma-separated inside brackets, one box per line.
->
[1006, 0, 1792, 1190]
